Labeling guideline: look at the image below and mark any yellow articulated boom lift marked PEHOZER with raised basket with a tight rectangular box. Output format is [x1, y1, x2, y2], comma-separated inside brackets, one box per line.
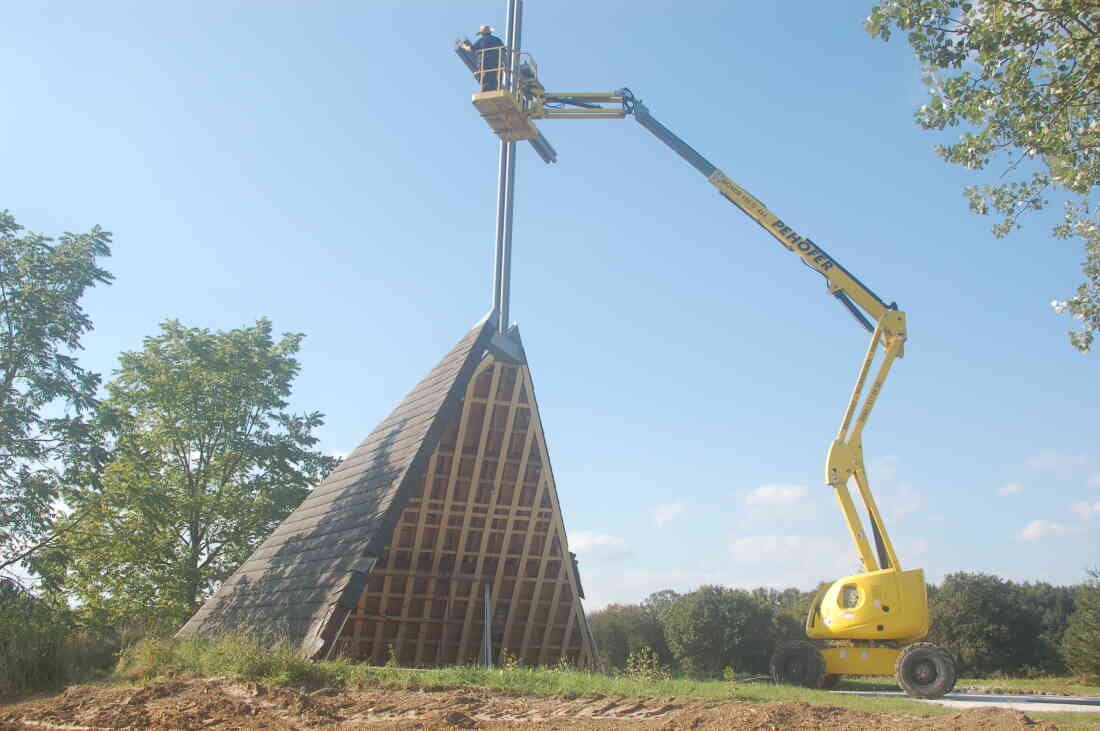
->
[457, 41, 956, 698]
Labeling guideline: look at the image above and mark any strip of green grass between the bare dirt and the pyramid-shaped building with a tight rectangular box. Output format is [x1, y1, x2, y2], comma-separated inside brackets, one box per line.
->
[105, 636, 1100, 729]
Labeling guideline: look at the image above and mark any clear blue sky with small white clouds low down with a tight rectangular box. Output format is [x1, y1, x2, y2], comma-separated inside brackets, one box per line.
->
[0, 0, 1100, 608]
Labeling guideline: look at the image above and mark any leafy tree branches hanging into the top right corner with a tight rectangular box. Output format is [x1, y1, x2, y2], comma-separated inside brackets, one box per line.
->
[866, 0, 1100, 352]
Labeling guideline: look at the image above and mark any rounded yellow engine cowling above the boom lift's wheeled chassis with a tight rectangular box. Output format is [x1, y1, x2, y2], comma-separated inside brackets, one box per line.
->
[806, 568, 928, 642]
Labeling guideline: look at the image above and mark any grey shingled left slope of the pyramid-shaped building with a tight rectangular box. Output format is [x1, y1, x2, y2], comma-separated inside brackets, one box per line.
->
[179, 313, 495, 657]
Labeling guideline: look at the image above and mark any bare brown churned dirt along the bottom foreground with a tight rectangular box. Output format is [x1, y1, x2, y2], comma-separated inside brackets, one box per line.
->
[0, 678, 1056, 731]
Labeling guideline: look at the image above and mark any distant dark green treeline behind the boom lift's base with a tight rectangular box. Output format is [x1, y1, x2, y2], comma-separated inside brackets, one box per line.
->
[590, 571, 1100, 678]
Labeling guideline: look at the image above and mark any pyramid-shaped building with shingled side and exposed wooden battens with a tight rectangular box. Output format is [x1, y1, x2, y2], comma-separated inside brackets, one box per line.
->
[179, 313, 595, 665]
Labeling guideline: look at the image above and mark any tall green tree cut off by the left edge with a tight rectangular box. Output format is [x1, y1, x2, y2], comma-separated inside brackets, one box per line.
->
[0, 210, 113, 572]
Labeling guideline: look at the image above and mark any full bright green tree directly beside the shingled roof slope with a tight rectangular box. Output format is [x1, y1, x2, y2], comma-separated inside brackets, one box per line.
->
[42, 320, 336, 628]
